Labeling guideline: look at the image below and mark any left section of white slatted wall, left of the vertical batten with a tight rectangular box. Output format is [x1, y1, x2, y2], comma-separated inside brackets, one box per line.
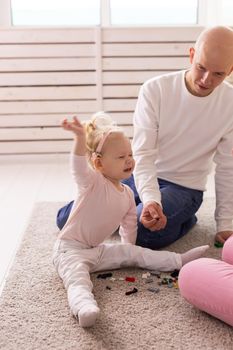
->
[0, 28, 98, 154]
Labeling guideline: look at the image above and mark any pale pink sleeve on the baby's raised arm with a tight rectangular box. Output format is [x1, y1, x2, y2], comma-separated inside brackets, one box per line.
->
[70, 153, 95, 189]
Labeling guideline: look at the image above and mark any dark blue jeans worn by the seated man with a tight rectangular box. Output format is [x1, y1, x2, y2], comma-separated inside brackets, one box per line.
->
[57, 176, 203, 249]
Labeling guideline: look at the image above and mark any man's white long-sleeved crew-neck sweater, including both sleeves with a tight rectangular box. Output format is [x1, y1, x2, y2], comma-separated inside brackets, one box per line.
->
[133, 71, 233, 232]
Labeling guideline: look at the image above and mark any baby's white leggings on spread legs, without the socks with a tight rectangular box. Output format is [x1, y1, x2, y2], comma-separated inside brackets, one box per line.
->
[53, 240, 182, 315]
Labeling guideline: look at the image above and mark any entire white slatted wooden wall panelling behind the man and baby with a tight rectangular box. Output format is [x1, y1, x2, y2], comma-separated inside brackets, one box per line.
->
[0, 27, 202, 154]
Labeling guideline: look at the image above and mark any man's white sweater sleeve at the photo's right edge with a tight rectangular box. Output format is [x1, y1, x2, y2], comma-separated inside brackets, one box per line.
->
[214, 128, 233, 232]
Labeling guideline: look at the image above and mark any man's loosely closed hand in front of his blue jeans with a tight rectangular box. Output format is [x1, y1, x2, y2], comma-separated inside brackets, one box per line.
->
[140, 202, 167, 231]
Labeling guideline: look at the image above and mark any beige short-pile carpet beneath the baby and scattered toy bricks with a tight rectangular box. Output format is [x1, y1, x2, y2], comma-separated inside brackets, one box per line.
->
[0, 199, 233, 350]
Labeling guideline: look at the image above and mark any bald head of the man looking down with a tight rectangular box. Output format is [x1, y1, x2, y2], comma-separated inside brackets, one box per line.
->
[185, 26, 233, 97]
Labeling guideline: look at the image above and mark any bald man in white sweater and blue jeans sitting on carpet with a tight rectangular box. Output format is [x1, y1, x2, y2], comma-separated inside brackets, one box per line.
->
[57, 27, 233, 249]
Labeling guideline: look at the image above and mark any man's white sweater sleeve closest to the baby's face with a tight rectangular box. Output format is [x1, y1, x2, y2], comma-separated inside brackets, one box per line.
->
[132, 80, 161, 204]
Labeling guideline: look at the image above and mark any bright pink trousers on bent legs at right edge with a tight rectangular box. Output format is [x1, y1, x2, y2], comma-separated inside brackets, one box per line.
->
[179, 236, 233, 326]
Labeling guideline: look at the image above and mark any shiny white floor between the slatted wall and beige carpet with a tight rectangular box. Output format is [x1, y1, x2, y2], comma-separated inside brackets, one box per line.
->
[0, 155, 214, 292]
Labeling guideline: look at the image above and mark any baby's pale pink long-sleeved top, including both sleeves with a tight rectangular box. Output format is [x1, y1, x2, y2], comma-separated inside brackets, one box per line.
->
[59, 154, 137, 247]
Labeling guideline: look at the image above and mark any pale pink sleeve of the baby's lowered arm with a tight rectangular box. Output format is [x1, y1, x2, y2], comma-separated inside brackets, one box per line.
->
[119, 186, 137, 244]
